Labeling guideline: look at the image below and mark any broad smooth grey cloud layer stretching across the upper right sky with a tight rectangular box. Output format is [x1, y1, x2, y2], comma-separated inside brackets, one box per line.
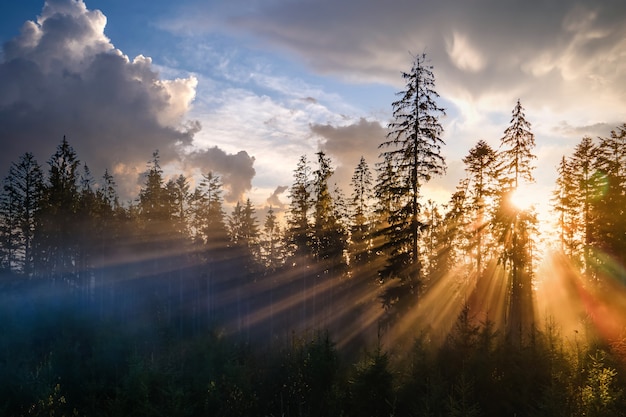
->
[174, 0, 626, 122]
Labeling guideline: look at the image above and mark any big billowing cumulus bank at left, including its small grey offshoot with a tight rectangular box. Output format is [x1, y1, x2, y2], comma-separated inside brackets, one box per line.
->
[0, 0, 254, 200]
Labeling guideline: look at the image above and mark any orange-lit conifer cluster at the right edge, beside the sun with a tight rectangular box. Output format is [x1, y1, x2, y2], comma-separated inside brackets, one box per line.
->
[554, 124, 626, 280]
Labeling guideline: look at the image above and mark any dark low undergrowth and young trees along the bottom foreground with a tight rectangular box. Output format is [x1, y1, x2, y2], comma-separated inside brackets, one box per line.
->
[0, 277, 626, 416]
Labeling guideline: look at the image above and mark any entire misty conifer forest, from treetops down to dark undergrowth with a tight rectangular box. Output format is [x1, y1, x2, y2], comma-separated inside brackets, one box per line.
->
[0, 55, 626, 416]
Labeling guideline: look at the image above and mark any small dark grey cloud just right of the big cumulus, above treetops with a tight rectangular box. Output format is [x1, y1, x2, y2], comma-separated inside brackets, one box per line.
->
[187, 147, 256, 203]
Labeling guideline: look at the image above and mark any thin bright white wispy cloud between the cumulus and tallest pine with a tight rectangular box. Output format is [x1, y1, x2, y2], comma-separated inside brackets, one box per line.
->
[183, 61, 354, 198]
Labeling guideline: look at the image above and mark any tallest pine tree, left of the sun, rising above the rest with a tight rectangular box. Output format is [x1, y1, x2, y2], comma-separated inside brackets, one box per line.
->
[378, 54, 446, 312]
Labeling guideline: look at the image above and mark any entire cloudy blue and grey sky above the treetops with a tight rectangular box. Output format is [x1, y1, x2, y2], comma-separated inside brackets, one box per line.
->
[0, 0, 626, 224]
